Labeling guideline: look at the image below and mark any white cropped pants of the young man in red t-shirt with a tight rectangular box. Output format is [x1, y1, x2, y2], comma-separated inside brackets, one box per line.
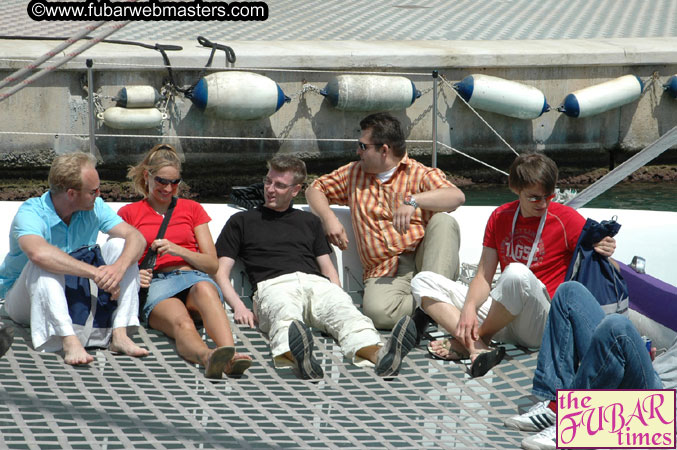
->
[411, 263, 550, 348]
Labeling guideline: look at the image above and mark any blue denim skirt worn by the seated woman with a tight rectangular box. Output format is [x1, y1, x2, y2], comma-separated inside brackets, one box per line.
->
[141, 270, 223, 324]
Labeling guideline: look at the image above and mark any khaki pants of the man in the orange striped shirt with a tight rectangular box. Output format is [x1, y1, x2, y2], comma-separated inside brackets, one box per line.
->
[363, 213, 461, 330]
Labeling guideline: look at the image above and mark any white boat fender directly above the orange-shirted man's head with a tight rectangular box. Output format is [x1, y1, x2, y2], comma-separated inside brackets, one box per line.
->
[320, 75, 421, 111]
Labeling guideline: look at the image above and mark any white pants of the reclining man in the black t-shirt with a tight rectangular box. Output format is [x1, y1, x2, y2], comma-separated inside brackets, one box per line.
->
[254, 272, 381, 367]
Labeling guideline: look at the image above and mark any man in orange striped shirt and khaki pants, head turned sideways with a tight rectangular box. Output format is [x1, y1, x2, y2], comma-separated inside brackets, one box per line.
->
[306, 113, 465, 329]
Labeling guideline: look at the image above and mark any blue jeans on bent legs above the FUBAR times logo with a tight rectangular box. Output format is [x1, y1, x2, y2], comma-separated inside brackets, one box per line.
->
[533, 281, 663, 400]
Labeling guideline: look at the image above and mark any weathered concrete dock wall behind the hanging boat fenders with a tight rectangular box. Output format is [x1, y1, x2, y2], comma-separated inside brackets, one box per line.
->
[0, 38, 677, 169]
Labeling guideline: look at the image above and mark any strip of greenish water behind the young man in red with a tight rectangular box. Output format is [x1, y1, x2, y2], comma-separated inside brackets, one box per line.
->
[463, 182, 677, 212]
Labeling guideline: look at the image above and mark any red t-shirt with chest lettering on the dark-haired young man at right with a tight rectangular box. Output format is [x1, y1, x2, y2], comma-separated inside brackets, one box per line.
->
[483, 200, 585, 298]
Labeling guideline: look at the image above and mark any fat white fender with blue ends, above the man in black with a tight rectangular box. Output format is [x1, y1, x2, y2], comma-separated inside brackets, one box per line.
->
[190, 71, 291, 120]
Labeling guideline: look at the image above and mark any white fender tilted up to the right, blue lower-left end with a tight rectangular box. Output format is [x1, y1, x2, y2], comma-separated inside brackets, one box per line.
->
[557, 75, 644, 118]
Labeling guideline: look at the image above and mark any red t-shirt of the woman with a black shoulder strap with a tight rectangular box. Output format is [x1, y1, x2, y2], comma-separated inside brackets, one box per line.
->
[118, 198, 212, 270]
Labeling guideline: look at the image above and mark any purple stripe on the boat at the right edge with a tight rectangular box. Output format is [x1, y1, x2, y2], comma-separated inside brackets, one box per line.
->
[618, 262, 677, 331]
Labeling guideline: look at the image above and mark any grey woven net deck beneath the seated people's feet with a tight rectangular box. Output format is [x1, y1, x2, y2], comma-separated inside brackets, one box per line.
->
[0, 312, 536, 449]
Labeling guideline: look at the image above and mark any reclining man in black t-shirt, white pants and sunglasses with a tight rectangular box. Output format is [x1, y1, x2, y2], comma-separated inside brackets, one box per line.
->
[215, 155, 416, 378]
